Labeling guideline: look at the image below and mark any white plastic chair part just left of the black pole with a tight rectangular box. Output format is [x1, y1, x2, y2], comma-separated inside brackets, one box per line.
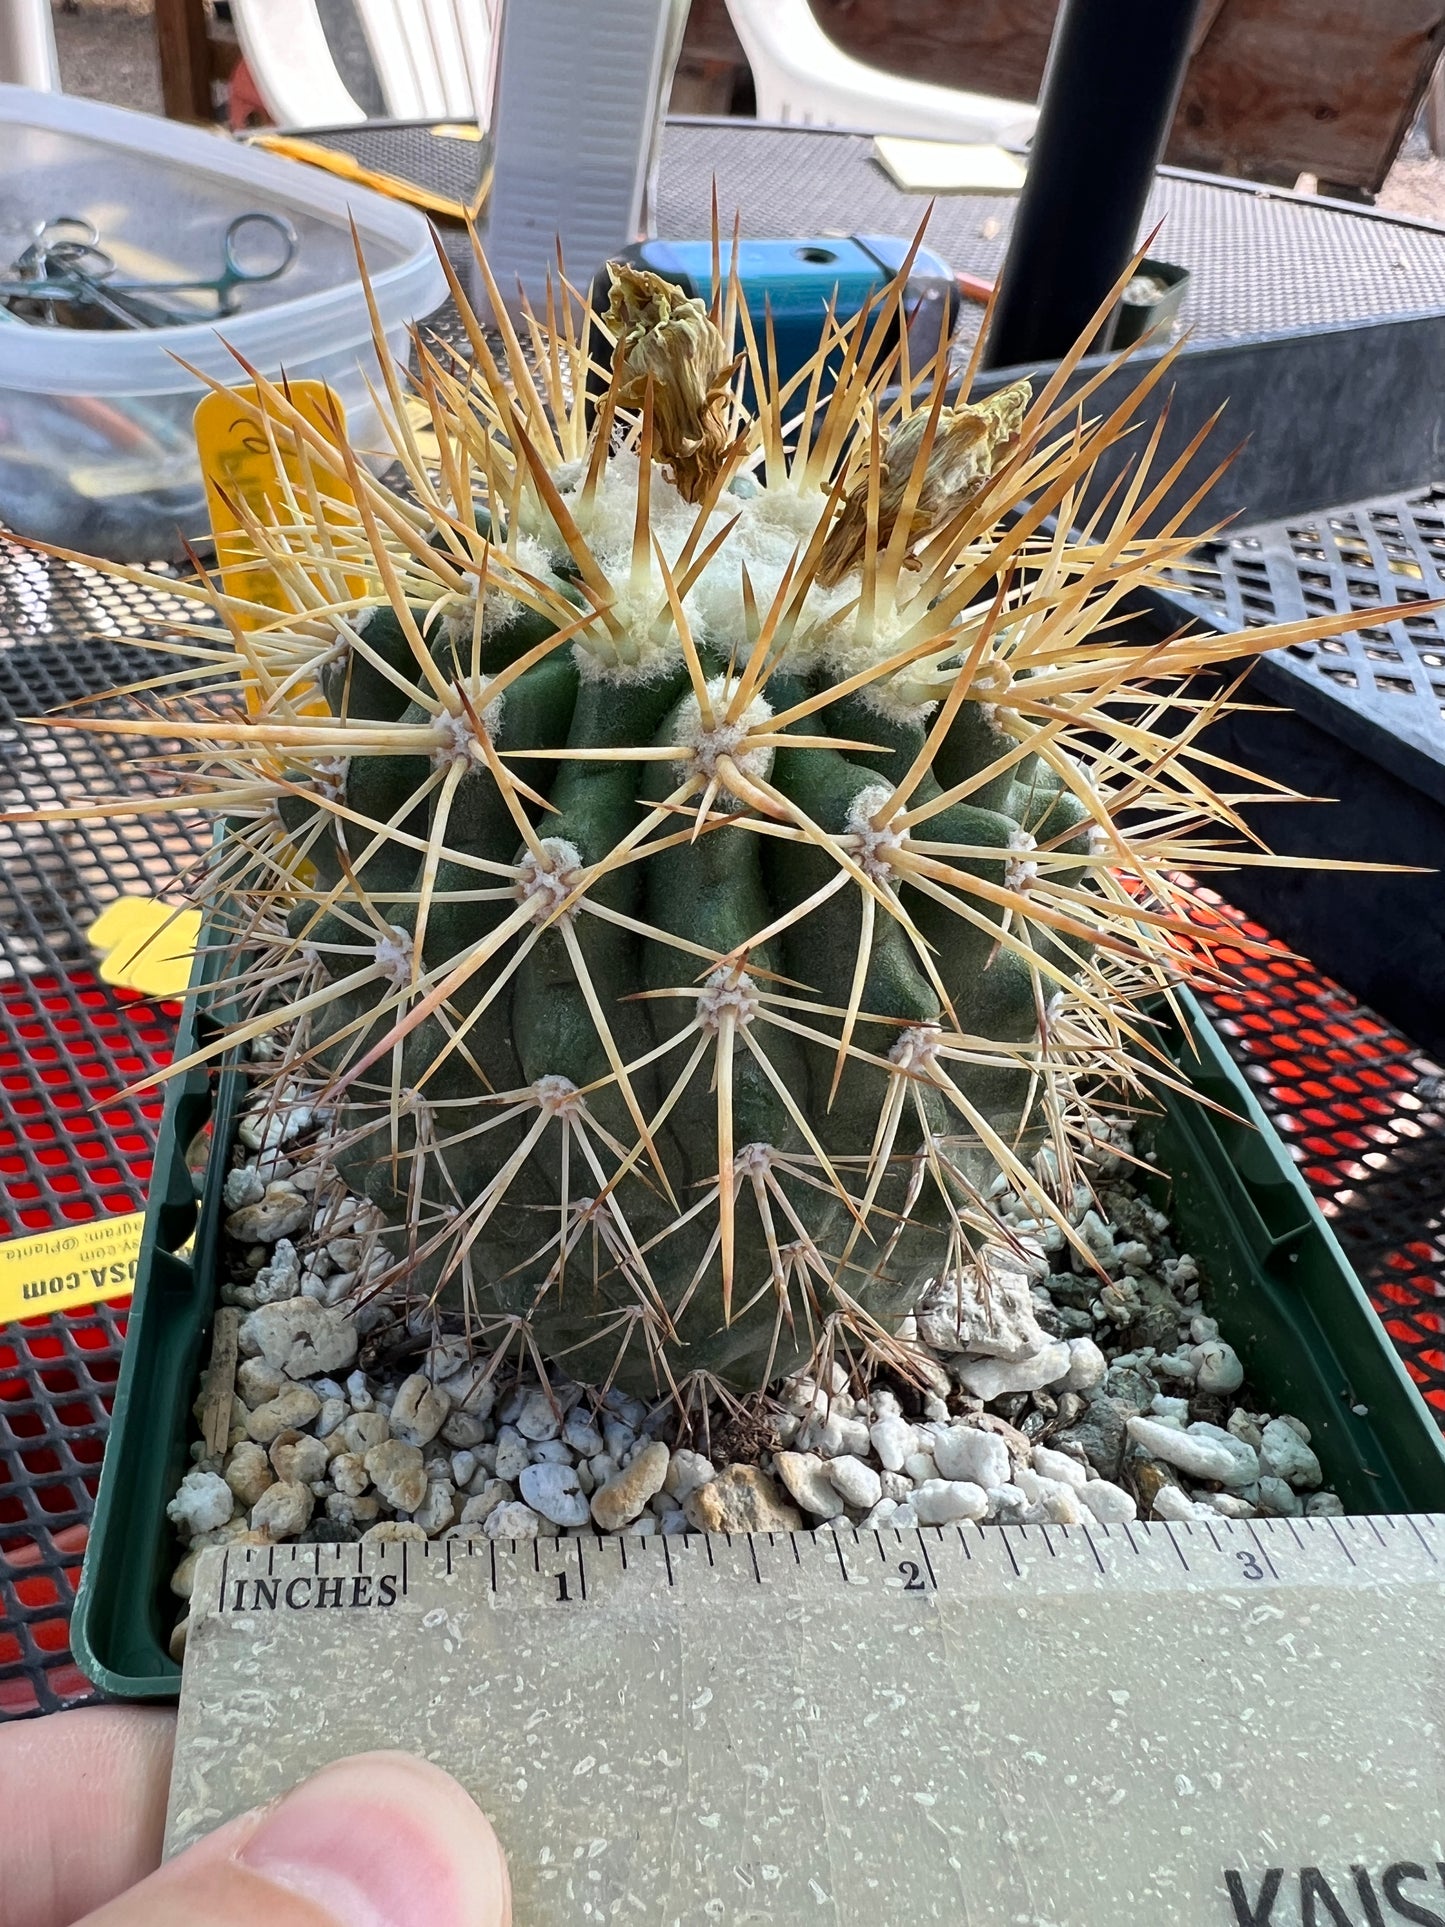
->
[726, 0, 1038, 148]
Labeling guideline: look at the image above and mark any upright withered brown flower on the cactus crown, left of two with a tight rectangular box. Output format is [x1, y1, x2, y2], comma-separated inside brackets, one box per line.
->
[607, 262, 732, 501]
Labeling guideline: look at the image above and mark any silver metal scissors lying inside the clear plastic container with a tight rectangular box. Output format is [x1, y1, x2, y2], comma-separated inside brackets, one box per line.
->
[0, 208, 301, 328]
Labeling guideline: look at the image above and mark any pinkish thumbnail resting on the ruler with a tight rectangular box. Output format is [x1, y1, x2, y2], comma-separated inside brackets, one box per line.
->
[237, 1754, 507, 1927]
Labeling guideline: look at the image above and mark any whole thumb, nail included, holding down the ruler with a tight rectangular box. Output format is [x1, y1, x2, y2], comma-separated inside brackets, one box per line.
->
[77, 1754, 512, 1927]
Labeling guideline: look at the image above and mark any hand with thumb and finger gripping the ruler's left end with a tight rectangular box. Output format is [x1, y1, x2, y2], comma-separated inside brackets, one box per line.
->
[0, 1707, 512, 1927]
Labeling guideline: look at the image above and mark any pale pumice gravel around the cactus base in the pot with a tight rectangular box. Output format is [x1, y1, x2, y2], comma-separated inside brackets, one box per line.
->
[168, 1100, 1343, 1597]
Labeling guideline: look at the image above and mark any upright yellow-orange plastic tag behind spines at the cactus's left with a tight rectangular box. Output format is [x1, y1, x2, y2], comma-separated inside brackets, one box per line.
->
[195, 380, 366, 715]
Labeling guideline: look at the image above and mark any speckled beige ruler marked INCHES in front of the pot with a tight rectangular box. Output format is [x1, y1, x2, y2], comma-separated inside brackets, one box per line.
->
[168, 1517, 1445, 1927]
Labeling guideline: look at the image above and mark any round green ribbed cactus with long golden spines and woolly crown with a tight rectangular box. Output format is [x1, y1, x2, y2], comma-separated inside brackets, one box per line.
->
[19, 233, 1379, 1397]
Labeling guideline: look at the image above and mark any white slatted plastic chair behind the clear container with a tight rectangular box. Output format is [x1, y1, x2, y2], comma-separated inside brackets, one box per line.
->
[236, 0, 497, 127]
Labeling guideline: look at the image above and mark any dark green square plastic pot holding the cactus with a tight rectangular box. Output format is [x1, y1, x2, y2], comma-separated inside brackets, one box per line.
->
[71, 987, 1445, 1700]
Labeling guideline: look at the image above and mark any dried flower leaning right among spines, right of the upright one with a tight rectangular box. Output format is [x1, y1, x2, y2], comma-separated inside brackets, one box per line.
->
[819, 380, 1033, 582]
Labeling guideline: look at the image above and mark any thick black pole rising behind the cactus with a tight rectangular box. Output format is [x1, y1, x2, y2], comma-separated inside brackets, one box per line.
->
[985, 0, 1200, 368]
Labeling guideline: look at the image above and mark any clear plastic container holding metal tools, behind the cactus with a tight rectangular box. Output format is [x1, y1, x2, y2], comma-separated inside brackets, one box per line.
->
[0, 87, 447, 563]
